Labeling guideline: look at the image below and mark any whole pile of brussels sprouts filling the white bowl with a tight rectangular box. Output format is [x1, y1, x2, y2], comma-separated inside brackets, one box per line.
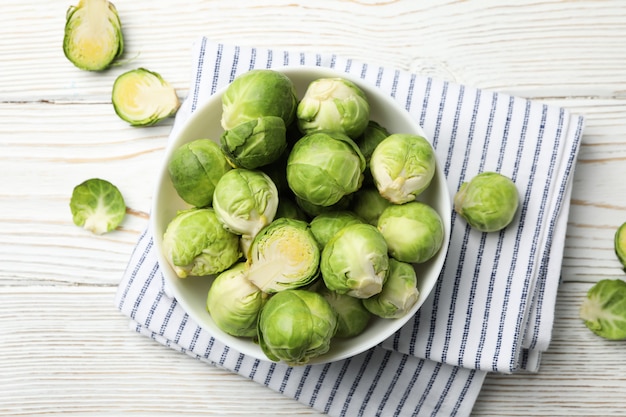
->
[163, 69, 445, 365]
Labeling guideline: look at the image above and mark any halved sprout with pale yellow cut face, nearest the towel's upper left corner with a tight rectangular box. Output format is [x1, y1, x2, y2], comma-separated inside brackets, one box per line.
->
[111, 68, 180, 126]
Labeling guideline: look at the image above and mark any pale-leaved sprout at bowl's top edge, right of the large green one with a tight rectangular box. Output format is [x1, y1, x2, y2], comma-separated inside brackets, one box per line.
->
[297, 78, 370, 138]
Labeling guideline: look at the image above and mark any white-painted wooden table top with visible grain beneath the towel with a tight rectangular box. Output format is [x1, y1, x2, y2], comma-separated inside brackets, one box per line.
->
[0, 0, 626, 416]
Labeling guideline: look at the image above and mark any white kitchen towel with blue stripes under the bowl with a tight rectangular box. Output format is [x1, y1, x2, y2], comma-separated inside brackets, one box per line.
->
[115, 38, 583, 416]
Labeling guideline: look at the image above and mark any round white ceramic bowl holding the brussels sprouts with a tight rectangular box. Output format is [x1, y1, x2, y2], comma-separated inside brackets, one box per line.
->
[151, 67, 451, 364]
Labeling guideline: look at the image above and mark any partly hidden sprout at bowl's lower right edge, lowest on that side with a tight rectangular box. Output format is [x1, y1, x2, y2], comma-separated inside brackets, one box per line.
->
[363, 258, 419, 319]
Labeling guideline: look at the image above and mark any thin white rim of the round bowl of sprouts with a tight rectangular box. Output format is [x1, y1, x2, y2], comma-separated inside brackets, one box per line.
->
[149, 65, 452, 365]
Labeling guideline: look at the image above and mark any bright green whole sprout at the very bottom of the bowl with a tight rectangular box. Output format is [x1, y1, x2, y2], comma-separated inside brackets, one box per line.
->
[258, 290, 337, 366]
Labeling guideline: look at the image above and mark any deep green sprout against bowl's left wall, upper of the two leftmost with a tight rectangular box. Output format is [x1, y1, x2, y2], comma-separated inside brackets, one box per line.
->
[167, 139, 231, 207]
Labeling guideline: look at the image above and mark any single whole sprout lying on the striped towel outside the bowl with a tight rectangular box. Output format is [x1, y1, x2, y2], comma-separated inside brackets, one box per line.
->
[454, 172, 519, 232]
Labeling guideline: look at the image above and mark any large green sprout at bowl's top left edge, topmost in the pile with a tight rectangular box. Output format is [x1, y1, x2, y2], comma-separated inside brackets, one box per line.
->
[221, 69, 298, 130]
